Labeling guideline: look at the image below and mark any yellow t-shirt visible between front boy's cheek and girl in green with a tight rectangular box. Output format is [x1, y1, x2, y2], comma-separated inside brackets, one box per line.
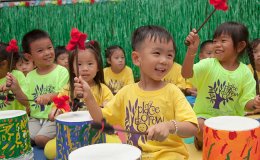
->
[163, 62, 186, 90]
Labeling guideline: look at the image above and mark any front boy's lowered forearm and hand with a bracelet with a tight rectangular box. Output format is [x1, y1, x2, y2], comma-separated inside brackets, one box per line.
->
[147, 121, 198, 141]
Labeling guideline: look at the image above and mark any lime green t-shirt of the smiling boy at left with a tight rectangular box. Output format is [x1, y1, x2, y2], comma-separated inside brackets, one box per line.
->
[26, 65, 69, 119]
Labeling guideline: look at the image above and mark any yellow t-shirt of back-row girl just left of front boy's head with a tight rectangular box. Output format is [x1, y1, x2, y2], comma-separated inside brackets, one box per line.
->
[104, 66, 134, 94]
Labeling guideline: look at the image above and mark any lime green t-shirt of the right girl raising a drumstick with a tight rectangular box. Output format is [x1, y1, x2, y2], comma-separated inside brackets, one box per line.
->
[189, 58, 256, 118]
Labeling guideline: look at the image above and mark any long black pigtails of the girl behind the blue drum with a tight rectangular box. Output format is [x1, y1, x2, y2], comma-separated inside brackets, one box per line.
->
[69, 40, 104, 100]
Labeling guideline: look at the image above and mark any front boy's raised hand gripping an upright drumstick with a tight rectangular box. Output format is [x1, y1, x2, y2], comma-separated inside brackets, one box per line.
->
[74, 76, 91, 99]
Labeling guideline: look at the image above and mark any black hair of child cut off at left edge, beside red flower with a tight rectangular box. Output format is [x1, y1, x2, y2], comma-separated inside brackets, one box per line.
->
[0, 42, 19, 71]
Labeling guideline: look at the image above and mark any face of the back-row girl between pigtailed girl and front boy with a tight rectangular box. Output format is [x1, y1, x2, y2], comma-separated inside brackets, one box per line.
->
[108, 49, 125, 73]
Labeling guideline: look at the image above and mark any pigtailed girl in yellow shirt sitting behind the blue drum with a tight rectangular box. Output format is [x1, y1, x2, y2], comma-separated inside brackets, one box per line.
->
[44, 38, 113, 159]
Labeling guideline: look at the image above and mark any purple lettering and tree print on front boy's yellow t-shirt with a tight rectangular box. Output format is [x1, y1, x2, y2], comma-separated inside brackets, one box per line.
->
[125, 99, 164, 150]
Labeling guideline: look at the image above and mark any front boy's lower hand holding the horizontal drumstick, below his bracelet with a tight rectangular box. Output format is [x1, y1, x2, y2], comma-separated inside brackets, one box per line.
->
[147, 122, 170, 141]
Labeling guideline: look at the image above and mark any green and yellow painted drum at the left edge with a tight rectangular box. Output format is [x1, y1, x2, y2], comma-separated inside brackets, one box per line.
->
[0, 110, 33, 160]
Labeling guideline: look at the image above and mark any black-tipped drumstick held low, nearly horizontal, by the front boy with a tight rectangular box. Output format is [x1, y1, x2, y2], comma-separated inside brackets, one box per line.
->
[90, 122, 148, 135]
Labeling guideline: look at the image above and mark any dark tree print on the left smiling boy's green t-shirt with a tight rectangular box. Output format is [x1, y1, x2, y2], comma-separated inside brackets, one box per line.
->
[32, 84, 55, 112]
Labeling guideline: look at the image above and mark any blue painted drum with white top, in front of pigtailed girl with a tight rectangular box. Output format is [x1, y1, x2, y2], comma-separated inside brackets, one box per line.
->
[56, 111, 105, 160]
